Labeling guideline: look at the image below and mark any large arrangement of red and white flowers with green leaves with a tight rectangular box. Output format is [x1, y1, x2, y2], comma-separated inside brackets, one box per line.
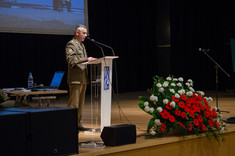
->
[138, 76, 225, 142]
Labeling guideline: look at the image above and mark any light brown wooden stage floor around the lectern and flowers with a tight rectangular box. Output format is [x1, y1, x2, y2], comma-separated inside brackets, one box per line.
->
[26, 91, 235, 156]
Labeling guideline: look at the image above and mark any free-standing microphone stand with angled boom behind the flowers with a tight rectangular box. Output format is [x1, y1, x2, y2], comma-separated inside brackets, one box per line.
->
[199, 48, 230, 113]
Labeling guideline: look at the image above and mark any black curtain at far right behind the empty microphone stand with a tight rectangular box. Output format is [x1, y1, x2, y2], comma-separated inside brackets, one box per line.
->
[170, 0, 235, 90]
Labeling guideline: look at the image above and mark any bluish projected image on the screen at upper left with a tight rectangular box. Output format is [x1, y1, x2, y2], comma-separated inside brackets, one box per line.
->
[0, 0, 86, 34]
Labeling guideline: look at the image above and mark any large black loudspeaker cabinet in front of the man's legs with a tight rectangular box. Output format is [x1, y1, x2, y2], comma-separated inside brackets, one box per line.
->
[7, 107, 78, 156]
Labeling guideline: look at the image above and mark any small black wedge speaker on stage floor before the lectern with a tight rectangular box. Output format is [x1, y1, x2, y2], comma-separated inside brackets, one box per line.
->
[100, 124, 136, 146]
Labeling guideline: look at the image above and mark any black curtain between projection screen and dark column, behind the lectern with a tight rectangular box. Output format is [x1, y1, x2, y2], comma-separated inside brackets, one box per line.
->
[88, 0, 157, 92]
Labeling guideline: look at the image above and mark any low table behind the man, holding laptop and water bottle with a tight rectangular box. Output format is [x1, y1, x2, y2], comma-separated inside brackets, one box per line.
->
[5, 90, 68, 106]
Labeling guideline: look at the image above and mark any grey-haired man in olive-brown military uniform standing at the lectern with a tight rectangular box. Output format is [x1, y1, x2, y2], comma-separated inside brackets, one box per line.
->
[65, 24, 96, 131]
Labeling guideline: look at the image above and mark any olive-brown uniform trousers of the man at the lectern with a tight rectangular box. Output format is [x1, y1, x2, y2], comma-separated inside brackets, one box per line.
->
[68, 84, 87, 127]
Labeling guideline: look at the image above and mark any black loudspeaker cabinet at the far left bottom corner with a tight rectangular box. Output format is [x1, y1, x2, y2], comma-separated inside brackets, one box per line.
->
[0, 110, 29, 156]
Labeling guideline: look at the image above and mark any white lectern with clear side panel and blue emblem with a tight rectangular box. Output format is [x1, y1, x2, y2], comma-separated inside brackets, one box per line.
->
[87, 56, 118, 131]
